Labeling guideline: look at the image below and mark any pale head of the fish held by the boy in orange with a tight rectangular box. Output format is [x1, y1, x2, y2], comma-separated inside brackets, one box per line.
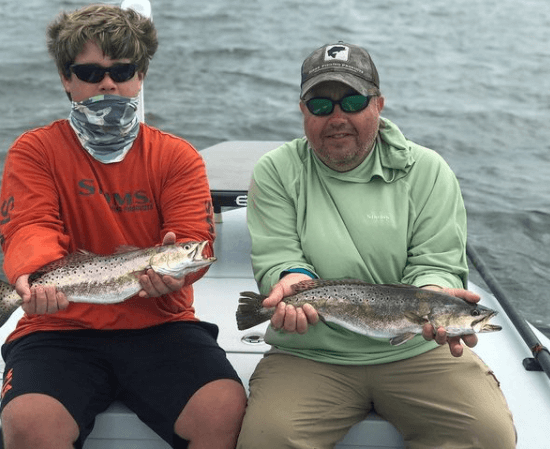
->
[150, 241, 216, 279]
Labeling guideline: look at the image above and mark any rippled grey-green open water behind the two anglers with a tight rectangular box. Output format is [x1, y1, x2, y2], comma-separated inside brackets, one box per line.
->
[0, 0, 550, 333]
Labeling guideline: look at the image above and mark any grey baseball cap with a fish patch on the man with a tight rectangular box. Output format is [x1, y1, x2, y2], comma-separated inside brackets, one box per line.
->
[300, 41, 380, 98]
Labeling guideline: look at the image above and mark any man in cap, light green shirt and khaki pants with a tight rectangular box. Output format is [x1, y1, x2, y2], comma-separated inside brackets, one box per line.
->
[238, 42, 515, 449]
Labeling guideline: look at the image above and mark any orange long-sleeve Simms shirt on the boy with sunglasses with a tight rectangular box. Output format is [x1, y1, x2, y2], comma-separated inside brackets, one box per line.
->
[0, 120, 214, 340]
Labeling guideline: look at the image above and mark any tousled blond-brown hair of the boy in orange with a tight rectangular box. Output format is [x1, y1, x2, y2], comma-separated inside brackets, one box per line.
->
[47, 4, 158, 78]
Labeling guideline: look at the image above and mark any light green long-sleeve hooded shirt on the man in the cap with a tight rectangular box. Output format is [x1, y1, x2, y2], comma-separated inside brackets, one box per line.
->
[247, 119, 468, 364]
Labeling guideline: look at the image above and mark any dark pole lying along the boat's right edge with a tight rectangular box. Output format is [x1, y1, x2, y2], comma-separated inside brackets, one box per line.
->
[466, 243, 550, 378]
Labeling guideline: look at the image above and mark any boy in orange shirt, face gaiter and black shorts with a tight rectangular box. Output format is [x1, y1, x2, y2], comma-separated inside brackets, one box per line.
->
[0, 5, 246, 449]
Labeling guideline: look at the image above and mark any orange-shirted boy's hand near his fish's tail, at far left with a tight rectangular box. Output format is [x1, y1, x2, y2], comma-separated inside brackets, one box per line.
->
[15, 274, 69, 315]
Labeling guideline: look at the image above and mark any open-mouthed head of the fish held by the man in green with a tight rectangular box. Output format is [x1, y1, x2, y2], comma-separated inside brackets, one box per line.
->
[429, 300, 502, 336]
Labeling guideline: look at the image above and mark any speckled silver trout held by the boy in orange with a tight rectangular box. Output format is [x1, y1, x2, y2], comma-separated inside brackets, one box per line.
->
[0, 242, 216, 326]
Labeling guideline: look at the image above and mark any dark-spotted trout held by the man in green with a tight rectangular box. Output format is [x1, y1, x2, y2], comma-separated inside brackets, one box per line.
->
[237, 279, 502, 346]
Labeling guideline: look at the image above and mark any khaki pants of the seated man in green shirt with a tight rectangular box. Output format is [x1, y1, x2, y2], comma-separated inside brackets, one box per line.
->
[237, 346, 516, 449]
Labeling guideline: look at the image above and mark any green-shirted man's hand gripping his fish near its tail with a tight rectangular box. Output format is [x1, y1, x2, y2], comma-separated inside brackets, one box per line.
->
[263, 273, 319, 334]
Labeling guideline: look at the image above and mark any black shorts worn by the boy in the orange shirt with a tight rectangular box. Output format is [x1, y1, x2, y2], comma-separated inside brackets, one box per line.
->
[2, 322, 241, 447]
